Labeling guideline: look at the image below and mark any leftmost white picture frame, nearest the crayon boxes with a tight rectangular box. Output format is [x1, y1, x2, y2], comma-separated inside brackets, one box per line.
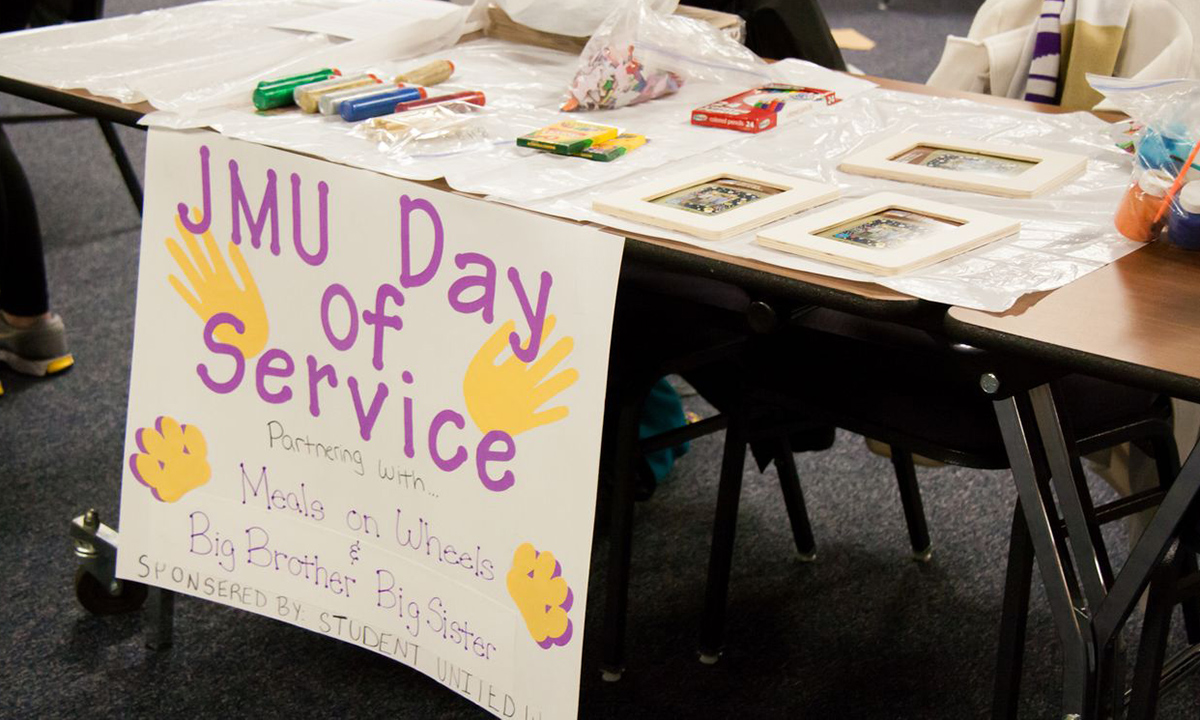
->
[592, 163, 841, 240]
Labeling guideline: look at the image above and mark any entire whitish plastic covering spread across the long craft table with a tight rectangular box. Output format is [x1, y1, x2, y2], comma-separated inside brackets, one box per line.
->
[0, 0, 1140, 311]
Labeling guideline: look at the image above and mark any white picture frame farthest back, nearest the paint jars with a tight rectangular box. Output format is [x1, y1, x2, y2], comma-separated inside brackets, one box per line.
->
[838, 133, 1087, 198]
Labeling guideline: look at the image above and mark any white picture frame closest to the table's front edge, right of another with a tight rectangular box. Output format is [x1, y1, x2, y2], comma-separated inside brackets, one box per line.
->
[755, 192, 1021, 275]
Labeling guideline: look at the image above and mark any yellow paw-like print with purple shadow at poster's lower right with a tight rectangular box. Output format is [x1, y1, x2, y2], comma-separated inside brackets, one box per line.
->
[506, 542, 575, 649]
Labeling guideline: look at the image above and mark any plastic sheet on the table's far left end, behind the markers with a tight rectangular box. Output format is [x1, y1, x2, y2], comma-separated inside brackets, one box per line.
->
[0, 0, 470, 114]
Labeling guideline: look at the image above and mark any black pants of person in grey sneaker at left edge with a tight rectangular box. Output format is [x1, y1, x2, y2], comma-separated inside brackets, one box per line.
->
[0, 0, 49, 316]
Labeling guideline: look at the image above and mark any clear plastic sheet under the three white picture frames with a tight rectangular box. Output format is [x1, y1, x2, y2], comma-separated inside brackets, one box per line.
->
[526, 90, 1142, 312]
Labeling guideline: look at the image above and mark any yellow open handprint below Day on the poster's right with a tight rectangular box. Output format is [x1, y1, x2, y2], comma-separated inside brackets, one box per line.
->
[462, 316, 580, 436]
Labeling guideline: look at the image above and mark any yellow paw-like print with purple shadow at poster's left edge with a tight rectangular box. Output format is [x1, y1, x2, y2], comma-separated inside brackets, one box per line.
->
[130, 416, 212, 503]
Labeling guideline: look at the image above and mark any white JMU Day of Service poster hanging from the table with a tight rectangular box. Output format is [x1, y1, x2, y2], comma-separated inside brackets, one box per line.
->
[118, 131, 622, 720]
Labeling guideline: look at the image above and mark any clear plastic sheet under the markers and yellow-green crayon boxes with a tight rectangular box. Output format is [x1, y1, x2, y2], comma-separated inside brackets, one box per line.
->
[138, 40, 874, 205]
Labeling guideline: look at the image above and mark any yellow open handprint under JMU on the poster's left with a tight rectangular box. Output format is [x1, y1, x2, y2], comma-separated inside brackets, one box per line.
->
[167, 210, 269, 358]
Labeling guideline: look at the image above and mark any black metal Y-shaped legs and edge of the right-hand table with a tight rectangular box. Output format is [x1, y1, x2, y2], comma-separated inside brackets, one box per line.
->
[944, 316, 1200, 720]
